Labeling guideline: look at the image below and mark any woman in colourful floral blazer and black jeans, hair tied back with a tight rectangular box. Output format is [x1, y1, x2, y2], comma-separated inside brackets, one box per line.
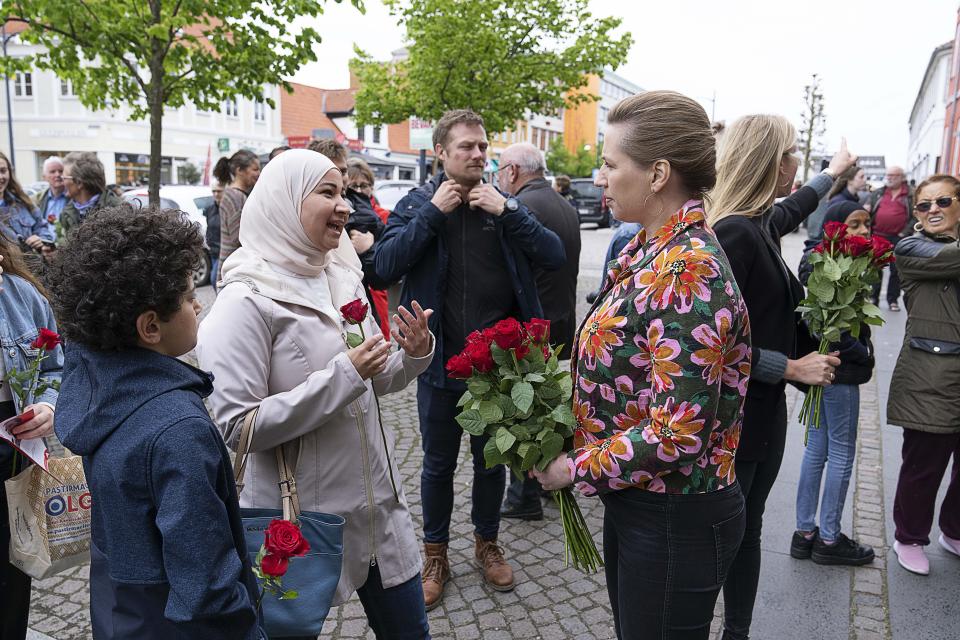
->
[536, 91, 751, 640]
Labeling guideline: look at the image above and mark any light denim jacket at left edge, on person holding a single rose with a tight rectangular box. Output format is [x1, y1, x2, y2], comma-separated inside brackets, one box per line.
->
[0, 273, 63, 413]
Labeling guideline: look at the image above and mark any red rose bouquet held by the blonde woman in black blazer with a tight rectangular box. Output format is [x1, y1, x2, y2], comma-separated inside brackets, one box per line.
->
[797, 222, 894, 445]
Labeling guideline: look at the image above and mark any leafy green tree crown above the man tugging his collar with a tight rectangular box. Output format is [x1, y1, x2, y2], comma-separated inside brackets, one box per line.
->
[351, 0, 633, 133]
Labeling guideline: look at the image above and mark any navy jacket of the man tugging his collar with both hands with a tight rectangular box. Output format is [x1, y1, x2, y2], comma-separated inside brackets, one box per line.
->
[374, 171, 566, 388]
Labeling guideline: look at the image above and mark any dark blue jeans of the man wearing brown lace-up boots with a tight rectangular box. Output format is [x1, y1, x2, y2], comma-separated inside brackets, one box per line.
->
[417, 382, 506, 544]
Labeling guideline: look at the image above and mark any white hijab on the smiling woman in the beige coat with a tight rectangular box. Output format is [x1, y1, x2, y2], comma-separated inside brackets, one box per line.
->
[220, 149, 363, 319]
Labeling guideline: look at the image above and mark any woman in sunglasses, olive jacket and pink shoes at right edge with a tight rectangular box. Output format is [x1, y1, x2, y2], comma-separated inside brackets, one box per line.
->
[887, 175, 960, 576]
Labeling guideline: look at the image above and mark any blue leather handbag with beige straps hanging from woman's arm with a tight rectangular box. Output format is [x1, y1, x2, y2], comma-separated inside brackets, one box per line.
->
[234, 409, 345, 638]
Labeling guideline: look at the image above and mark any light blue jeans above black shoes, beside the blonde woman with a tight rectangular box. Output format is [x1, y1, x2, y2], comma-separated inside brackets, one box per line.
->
[797, 384, 860, 542]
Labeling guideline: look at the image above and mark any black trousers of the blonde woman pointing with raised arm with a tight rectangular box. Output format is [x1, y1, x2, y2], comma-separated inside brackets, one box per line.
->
[723, 397, 787, 640]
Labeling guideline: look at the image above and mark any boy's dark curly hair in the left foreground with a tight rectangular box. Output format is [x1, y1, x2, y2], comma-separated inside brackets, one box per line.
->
[44, 207, 204, 350]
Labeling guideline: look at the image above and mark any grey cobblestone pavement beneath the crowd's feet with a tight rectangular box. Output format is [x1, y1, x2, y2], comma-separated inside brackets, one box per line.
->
[31, 230, 916, 640]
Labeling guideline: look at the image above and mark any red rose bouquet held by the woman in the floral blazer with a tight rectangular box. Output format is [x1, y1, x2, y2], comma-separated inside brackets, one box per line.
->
[447, 318, 603, 573]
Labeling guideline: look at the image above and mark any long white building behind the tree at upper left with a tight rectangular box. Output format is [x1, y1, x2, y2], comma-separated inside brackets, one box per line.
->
[0, 37, 283, 184]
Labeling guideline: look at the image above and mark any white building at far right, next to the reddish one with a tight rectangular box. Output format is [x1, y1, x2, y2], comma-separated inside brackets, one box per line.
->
[904, 41, 953, 183]
